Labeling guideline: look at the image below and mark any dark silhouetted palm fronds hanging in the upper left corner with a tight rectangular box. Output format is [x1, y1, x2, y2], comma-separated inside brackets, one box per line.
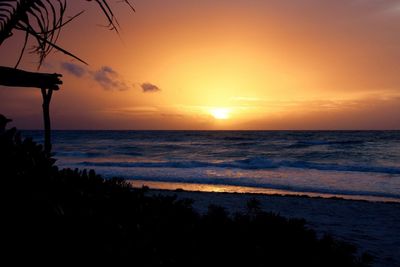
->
[0, 0, 134, 66]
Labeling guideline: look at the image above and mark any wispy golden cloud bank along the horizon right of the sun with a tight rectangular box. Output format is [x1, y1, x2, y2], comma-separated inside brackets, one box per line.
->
[240, 96, 400, 130]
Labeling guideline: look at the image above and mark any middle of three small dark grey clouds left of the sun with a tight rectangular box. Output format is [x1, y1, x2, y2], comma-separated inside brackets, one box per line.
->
[92, 66, 130, 91]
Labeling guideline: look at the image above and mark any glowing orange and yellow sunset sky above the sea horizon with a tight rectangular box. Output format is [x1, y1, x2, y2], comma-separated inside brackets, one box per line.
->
[0, 0, 400, 130]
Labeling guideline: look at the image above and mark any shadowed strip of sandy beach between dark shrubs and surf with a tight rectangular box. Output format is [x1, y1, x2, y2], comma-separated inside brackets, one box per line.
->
[149, 190, 400, 267]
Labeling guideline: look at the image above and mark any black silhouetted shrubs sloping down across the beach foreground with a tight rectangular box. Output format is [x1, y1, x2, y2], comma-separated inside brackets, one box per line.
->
[0, 126, 370, 267]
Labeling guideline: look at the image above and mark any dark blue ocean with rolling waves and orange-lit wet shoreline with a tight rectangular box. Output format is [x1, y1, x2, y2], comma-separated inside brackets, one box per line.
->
[23, 131, 400, 202]
